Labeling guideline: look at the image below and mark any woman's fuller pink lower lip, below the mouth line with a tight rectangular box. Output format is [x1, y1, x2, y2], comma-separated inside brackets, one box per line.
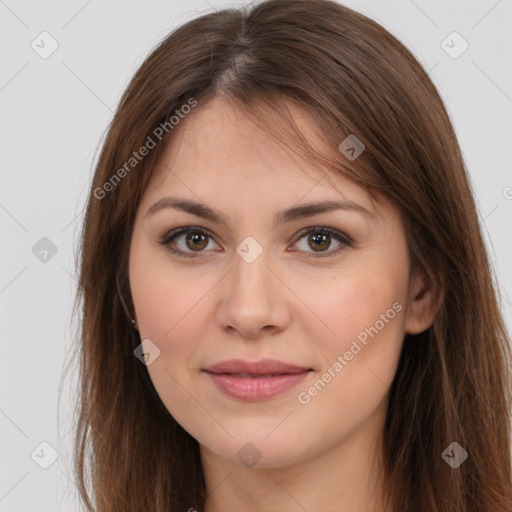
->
[202, 371, 310, 400]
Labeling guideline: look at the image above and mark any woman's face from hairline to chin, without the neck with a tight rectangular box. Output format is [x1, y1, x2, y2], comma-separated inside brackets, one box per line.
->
[129, 99, 422, 467]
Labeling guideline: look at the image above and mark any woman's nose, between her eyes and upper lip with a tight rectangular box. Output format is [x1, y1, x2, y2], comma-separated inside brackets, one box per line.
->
[215, 245, 291, 339]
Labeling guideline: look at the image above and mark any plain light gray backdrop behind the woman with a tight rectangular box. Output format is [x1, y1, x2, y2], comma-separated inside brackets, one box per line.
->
[0, 0, 512, 512]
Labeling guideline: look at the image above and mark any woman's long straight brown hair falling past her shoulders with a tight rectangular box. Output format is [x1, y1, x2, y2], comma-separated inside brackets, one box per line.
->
[69, 0, 512, 512]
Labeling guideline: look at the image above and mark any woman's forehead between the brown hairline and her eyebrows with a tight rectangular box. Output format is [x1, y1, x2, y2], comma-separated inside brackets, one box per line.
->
[140, 98, 375, 212]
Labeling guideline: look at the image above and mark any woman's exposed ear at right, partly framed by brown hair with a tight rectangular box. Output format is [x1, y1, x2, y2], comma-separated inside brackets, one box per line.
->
[405, 269, 444, 334]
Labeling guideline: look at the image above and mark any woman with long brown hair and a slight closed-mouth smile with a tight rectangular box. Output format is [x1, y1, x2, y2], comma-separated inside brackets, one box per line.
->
[72, 0, 512, 512]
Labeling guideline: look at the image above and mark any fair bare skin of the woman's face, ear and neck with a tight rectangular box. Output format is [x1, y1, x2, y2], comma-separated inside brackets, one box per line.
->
[129, 98, 435, 512]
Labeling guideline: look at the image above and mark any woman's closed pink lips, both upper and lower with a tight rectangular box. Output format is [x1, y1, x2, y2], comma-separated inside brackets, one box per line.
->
[204, 359, 312, 400]
